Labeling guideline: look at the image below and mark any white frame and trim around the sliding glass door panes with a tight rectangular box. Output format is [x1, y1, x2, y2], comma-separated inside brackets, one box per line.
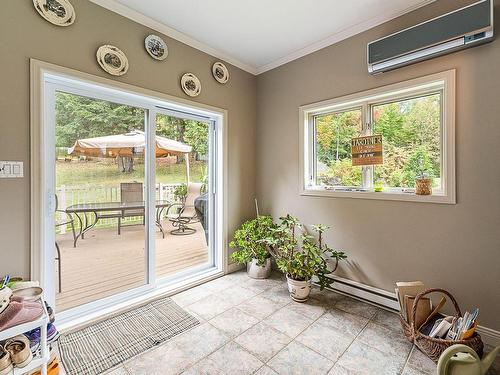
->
[30, 59, 228, 321]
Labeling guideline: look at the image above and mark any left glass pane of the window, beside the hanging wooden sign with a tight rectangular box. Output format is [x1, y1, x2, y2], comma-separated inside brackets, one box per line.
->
[314, 109, 362, 187]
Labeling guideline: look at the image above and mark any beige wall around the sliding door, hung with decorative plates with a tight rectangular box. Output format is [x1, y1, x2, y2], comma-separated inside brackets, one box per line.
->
[0, 0, 256, 276]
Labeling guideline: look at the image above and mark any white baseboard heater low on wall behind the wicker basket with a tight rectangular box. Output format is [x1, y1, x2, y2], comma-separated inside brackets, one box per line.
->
[322, 276, 500, 346]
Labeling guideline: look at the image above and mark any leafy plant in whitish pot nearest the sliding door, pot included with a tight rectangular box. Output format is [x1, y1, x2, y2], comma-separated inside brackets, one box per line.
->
[229, 216, 275, 279]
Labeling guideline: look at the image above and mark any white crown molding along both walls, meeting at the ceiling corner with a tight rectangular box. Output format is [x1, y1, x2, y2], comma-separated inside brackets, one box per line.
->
[90, 0, 436, 75]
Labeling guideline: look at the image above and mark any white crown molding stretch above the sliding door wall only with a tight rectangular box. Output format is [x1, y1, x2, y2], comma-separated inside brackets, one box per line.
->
[89, 0, 257, 75]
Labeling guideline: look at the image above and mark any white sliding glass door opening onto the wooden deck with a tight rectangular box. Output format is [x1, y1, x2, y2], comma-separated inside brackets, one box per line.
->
[43, 71, 222, 317]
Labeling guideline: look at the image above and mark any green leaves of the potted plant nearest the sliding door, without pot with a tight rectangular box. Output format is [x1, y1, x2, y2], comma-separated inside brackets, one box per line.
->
[229, 216, 276, 266]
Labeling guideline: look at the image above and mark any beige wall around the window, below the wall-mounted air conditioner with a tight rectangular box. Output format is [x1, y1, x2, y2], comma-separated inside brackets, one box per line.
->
[257, 0, 500, 330]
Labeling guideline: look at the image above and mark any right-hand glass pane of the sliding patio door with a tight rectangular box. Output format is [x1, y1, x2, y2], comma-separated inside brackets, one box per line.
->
[155, 114, 211, 278]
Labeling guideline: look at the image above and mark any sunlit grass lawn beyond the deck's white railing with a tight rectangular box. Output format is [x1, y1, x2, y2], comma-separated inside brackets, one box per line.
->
[56, 160, 206, 187]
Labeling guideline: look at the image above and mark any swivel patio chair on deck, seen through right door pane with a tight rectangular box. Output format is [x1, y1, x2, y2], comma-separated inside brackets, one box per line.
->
[167, 183, 203, 235]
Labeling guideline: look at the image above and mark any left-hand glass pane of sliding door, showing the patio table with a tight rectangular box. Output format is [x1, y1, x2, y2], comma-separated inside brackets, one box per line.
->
[54, 92, 147, 312]
